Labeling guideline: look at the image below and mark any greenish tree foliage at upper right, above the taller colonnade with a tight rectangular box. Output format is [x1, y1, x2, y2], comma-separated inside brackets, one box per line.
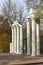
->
[25, 0, 43, 18]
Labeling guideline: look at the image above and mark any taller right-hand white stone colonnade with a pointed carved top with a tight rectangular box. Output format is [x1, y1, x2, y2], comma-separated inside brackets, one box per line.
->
[27, 8, 40, 56]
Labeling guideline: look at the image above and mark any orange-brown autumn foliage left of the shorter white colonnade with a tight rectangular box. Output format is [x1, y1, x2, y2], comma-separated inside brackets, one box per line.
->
[0, 21, 11, 53]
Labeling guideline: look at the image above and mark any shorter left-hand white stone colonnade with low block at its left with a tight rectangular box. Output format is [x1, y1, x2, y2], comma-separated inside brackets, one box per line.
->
[10, 21, 23, 54]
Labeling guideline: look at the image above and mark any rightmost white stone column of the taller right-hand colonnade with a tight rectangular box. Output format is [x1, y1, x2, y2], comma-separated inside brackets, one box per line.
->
[36, 23, 40, 55]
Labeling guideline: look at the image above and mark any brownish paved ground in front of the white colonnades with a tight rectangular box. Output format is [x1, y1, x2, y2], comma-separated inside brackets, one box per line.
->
[0, 53, 43, 65]
